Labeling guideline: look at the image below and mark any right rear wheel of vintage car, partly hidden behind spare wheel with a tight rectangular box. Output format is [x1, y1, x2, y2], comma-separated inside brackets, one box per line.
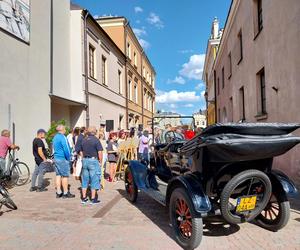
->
[255, 190, 290, 231]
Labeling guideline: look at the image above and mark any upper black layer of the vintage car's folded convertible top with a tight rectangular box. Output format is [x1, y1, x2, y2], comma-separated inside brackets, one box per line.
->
[201, 123, 300, 136]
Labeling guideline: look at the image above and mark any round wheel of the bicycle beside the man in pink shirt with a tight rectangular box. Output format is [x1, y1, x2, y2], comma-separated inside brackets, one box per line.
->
[11, 162, 30, 186]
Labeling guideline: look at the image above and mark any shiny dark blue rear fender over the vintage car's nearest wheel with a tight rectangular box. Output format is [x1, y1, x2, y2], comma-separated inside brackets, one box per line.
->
[166, 174, 211, 217]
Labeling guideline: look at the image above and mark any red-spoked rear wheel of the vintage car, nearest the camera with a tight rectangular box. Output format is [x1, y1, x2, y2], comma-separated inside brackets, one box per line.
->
[169, 188, 203, 249]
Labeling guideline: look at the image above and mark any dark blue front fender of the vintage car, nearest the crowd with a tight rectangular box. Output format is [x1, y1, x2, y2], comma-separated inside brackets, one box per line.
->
[128, 161, 148, 190]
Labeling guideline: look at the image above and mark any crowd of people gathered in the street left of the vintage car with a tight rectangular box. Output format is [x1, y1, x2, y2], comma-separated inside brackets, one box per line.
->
[0, 121, 198, 204]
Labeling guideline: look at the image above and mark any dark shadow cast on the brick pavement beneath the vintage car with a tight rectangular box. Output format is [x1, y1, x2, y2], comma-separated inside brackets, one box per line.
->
[117, 189, 240, 241]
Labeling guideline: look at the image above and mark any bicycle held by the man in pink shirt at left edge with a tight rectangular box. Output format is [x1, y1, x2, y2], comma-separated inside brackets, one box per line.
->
[3, 150, 30, 186]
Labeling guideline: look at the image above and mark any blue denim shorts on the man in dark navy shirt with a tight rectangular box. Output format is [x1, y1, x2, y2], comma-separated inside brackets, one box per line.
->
[81, 158, 101, 190]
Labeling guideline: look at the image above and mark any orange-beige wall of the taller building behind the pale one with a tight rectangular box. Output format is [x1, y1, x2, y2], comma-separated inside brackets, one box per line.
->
[97, 17, 155, 128]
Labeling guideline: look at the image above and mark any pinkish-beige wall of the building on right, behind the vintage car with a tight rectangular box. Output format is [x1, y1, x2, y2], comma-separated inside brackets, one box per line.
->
[214, 0, 300, 184]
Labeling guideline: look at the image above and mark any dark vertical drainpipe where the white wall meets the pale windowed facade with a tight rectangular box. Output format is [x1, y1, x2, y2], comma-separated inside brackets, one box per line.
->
[83, 9, 90, 127]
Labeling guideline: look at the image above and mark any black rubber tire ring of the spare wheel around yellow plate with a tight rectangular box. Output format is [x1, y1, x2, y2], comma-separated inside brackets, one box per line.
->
[220, 169, 272, 224]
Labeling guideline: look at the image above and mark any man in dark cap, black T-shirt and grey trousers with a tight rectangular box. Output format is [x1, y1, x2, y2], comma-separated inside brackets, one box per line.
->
[29, 129, 51, 192]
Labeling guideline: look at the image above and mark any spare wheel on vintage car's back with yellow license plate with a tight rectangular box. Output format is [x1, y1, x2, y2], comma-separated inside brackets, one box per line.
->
[220, 169, 272, 224]
